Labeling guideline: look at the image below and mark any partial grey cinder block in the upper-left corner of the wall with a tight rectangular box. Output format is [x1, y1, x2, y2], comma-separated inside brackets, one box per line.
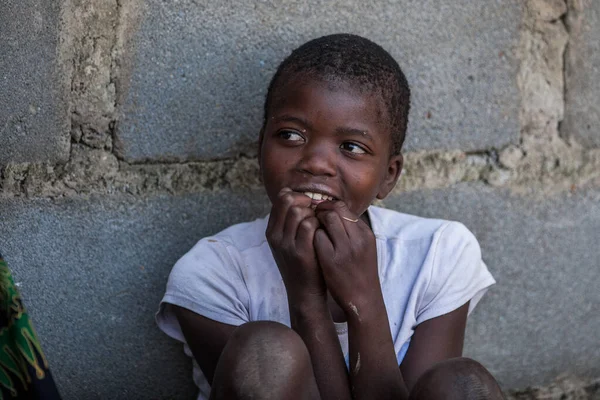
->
[0, 0, 70, 166]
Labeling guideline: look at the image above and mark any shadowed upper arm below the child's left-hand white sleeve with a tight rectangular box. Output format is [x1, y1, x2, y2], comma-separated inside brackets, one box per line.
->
[172, 306, 237, 385]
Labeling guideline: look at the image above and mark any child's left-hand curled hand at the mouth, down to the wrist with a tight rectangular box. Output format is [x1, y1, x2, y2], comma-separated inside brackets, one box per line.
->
[266, 188, 327, 306]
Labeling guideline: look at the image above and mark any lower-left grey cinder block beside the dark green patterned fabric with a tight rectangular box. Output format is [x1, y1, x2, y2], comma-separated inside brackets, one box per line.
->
[0, 192, 268, 400]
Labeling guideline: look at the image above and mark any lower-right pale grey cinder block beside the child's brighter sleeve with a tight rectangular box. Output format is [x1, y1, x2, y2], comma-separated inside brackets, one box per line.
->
[386, 185, 600, 388]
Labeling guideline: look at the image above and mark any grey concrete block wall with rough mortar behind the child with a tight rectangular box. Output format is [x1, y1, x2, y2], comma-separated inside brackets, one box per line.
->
[0, 0, 600, 399]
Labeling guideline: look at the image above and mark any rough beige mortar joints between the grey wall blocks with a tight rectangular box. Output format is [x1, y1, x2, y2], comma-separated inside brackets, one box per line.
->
[0, 0, 600, 198]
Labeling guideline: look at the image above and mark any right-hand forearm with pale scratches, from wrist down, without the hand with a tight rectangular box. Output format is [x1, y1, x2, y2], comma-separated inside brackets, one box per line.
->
[347, 298, 408, 400]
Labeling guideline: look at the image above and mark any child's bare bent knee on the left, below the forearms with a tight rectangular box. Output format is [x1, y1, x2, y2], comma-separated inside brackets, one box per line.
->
[210, 321, 320, 400]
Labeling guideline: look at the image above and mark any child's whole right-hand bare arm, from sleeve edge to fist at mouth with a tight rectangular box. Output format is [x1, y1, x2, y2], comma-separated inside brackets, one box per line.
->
[315, 202, 468, 399]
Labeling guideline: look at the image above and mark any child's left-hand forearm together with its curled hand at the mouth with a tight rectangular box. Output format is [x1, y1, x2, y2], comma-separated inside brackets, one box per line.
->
[267, 189, 350, 399]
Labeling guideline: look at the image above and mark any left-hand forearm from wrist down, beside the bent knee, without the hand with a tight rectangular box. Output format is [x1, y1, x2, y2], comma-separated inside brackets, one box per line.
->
[290, 299, 351, 400]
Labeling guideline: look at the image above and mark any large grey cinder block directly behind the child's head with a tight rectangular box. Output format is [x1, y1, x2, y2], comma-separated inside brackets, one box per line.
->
[118, 0, 522, 161]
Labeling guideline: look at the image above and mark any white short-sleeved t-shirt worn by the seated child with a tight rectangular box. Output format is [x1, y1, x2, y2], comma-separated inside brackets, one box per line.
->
[156, 206, 495, 399]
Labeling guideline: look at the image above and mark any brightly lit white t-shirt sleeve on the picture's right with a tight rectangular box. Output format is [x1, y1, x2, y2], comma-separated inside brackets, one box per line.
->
[416, 222, 496, 325]
